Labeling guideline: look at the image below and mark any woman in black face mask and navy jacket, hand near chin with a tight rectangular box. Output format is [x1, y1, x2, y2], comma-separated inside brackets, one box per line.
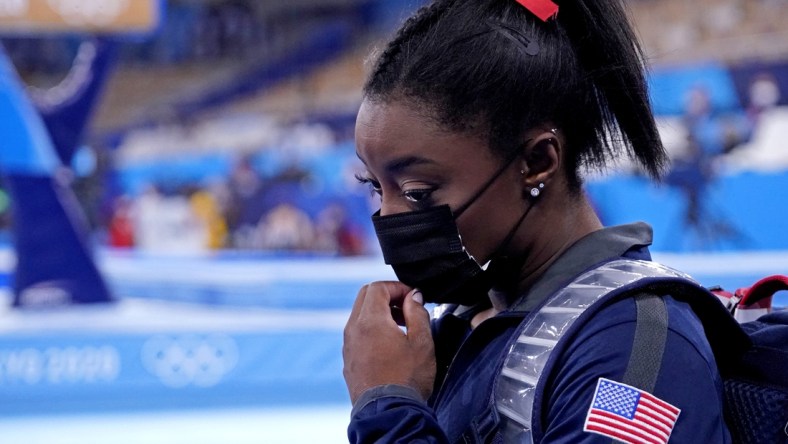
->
[344, 0, 729, 443]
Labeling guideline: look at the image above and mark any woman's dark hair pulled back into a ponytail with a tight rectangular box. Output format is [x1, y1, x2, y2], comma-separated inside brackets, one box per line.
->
[364, 0, 667, 190]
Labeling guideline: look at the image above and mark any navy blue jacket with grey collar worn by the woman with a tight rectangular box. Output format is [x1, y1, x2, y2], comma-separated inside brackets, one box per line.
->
[348, 224, 730, 444]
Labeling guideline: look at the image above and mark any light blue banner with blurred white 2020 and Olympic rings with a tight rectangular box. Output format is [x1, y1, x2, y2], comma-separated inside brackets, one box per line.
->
[0, 330, 349, 415]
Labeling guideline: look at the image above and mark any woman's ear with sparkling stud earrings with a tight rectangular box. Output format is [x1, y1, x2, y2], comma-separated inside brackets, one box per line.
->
[521, 130, 564, 191]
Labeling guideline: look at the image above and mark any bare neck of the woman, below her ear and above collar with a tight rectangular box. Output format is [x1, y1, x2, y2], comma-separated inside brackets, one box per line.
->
[490, 196, 602, 313]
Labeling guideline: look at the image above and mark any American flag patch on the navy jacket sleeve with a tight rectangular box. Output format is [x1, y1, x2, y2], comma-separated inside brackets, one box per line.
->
[583, 378, 681, 444]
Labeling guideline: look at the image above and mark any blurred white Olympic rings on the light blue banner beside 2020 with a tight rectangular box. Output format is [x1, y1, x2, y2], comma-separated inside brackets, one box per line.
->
[142, 334, 238, 388]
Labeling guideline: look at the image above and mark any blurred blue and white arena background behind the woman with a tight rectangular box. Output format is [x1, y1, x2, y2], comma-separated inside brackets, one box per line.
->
[0, 0, 788, 444]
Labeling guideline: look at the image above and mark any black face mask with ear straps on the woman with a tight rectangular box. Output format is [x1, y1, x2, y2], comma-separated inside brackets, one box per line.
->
[372, 146, 532, 305]
